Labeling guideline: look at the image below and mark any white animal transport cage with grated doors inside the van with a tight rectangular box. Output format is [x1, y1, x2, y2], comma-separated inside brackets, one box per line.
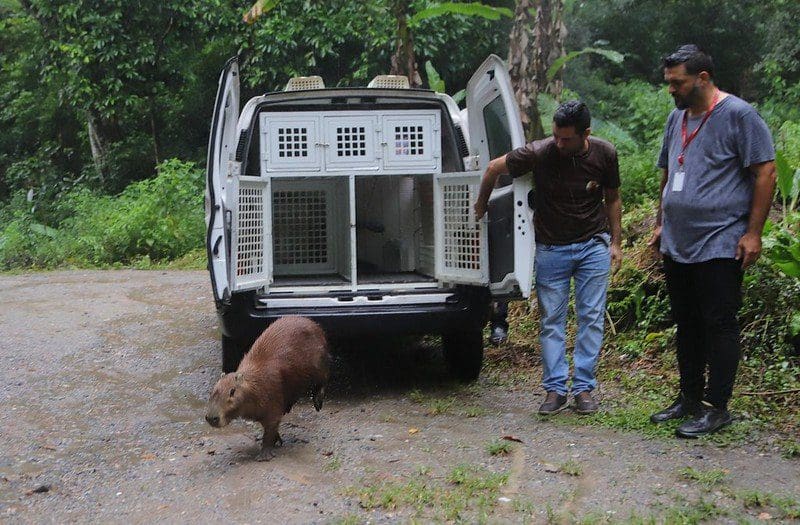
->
[232, 110, 468, 291]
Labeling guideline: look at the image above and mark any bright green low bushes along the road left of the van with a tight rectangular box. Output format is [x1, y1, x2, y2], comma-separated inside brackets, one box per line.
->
[0, 160, 204, 269]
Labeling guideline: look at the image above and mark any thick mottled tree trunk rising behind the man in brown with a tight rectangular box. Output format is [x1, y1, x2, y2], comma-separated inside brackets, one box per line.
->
[508, 0, 566, 140]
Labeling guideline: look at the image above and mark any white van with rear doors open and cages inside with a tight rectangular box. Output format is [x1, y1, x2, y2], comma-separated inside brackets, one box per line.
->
[206, 55, 535, 380]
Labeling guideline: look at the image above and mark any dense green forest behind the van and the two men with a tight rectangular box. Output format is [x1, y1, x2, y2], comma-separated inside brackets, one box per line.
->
[0, 0, 800, 446]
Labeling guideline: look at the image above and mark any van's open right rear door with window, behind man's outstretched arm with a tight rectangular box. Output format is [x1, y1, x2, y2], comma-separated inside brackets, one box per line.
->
[467, 55, 536, 297]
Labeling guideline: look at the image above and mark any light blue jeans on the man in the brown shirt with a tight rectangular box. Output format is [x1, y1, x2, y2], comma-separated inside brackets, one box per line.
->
[535, 233, 611, 395]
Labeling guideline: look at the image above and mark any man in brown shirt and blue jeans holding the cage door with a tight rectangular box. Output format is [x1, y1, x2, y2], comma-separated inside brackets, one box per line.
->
[475, 100, 622, 414]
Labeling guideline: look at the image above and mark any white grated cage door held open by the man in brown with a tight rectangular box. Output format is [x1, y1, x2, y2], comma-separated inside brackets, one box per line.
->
[433, 171, 489, 285]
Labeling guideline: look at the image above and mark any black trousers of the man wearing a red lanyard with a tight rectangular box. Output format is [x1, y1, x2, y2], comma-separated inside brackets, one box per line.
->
[664, 256, 742, 409]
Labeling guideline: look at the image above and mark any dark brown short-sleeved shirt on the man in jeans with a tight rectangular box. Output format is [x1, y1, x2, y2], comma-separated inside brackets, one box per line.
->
[506, 136, 619, 245]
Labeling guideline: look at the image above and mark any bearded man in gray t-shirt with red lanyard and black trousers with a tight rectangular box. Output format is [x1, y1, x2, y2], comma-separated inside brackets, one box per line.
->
[650, 45, 775, 438]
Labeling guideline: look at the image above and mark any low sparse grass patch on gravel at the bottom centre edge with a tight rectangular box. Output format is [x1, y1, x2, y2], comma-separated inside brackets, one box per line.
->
[347, 465, 508, 522]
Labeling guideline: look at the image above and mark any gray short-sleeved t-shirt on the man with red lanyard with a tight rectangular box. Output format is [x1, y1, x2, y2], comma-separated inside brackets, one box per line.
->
[658, 95, 775, 263]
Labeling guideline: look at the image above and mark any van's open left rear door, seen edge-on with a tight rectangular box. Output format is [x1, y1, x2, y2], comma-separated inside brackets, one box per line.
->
[205, 57, 239, 302]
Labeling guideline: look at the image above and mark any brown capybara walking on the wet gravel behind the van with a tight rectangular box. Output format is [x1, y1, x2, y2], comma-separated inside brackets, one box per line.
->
[206, 316, 330, 461]
